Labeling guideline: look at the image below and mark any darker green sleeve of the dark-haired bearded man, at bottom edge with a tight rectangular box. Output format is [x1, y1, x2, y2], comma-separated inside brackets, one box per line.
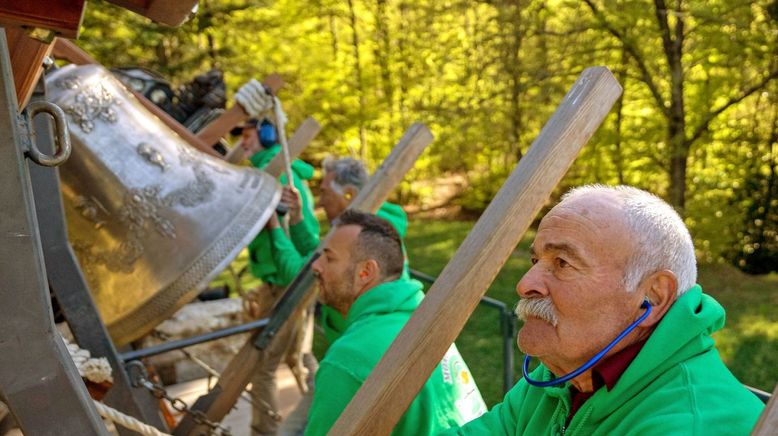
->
[305, 361, 362, 436]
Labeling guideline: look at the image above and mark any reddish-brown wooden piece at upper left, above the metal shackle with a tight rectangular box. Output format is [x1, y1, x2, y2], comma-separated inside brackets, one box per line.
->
[5, 27, 52, 110]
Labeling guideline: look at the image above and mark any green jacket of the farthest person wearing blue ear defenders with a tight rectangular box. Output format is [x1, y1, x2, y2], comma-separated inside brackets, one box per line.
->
[248, 144, 319, 286]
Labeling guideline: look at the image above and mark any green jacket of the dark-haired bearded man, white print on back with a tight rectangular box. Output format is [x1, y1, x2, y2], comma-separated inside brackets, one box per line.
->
[305, 279, 486, 435]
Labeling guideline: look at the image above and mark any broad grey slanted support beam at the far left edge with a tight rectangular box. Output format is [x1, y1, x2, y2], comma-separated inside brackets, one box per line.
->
[0, 27, 108, 435]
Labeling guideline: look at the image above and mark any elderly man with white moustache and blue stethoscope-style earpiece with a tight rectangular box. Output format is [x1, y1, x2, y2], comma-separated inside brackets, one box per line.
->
[450, 185, 763, 435]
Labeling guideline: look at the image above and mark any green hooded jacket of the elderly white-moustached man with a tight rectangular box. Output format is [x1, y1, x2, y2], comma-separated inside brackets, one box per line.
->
[449, 286, 764, 436]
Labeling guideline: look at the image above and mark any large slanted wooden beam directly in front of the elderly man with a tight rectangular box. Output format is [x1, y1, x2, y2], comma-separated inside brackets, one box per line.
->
[329, 67, 621, 435]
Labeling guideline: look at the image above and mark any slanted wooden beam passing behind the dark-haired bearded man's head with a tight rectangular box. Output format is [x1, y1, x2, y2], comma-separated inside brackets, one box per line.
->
[173, 123, 432, 435]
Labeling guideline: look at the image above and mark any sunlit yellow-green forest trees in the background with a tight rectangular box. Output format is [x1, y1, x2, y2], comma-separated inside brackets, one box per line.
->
[78, 0, 778, 404]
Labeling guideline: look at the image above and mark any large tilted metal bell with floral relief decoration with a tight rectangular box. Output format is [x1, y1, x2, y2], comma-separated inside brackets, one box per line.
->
[46, 65, 280, 345]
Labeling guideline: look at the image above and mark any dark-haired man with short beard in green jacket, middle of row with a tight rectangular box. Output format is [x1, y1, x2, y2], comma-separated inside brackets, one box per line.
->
[305, 210, 486, 435]
